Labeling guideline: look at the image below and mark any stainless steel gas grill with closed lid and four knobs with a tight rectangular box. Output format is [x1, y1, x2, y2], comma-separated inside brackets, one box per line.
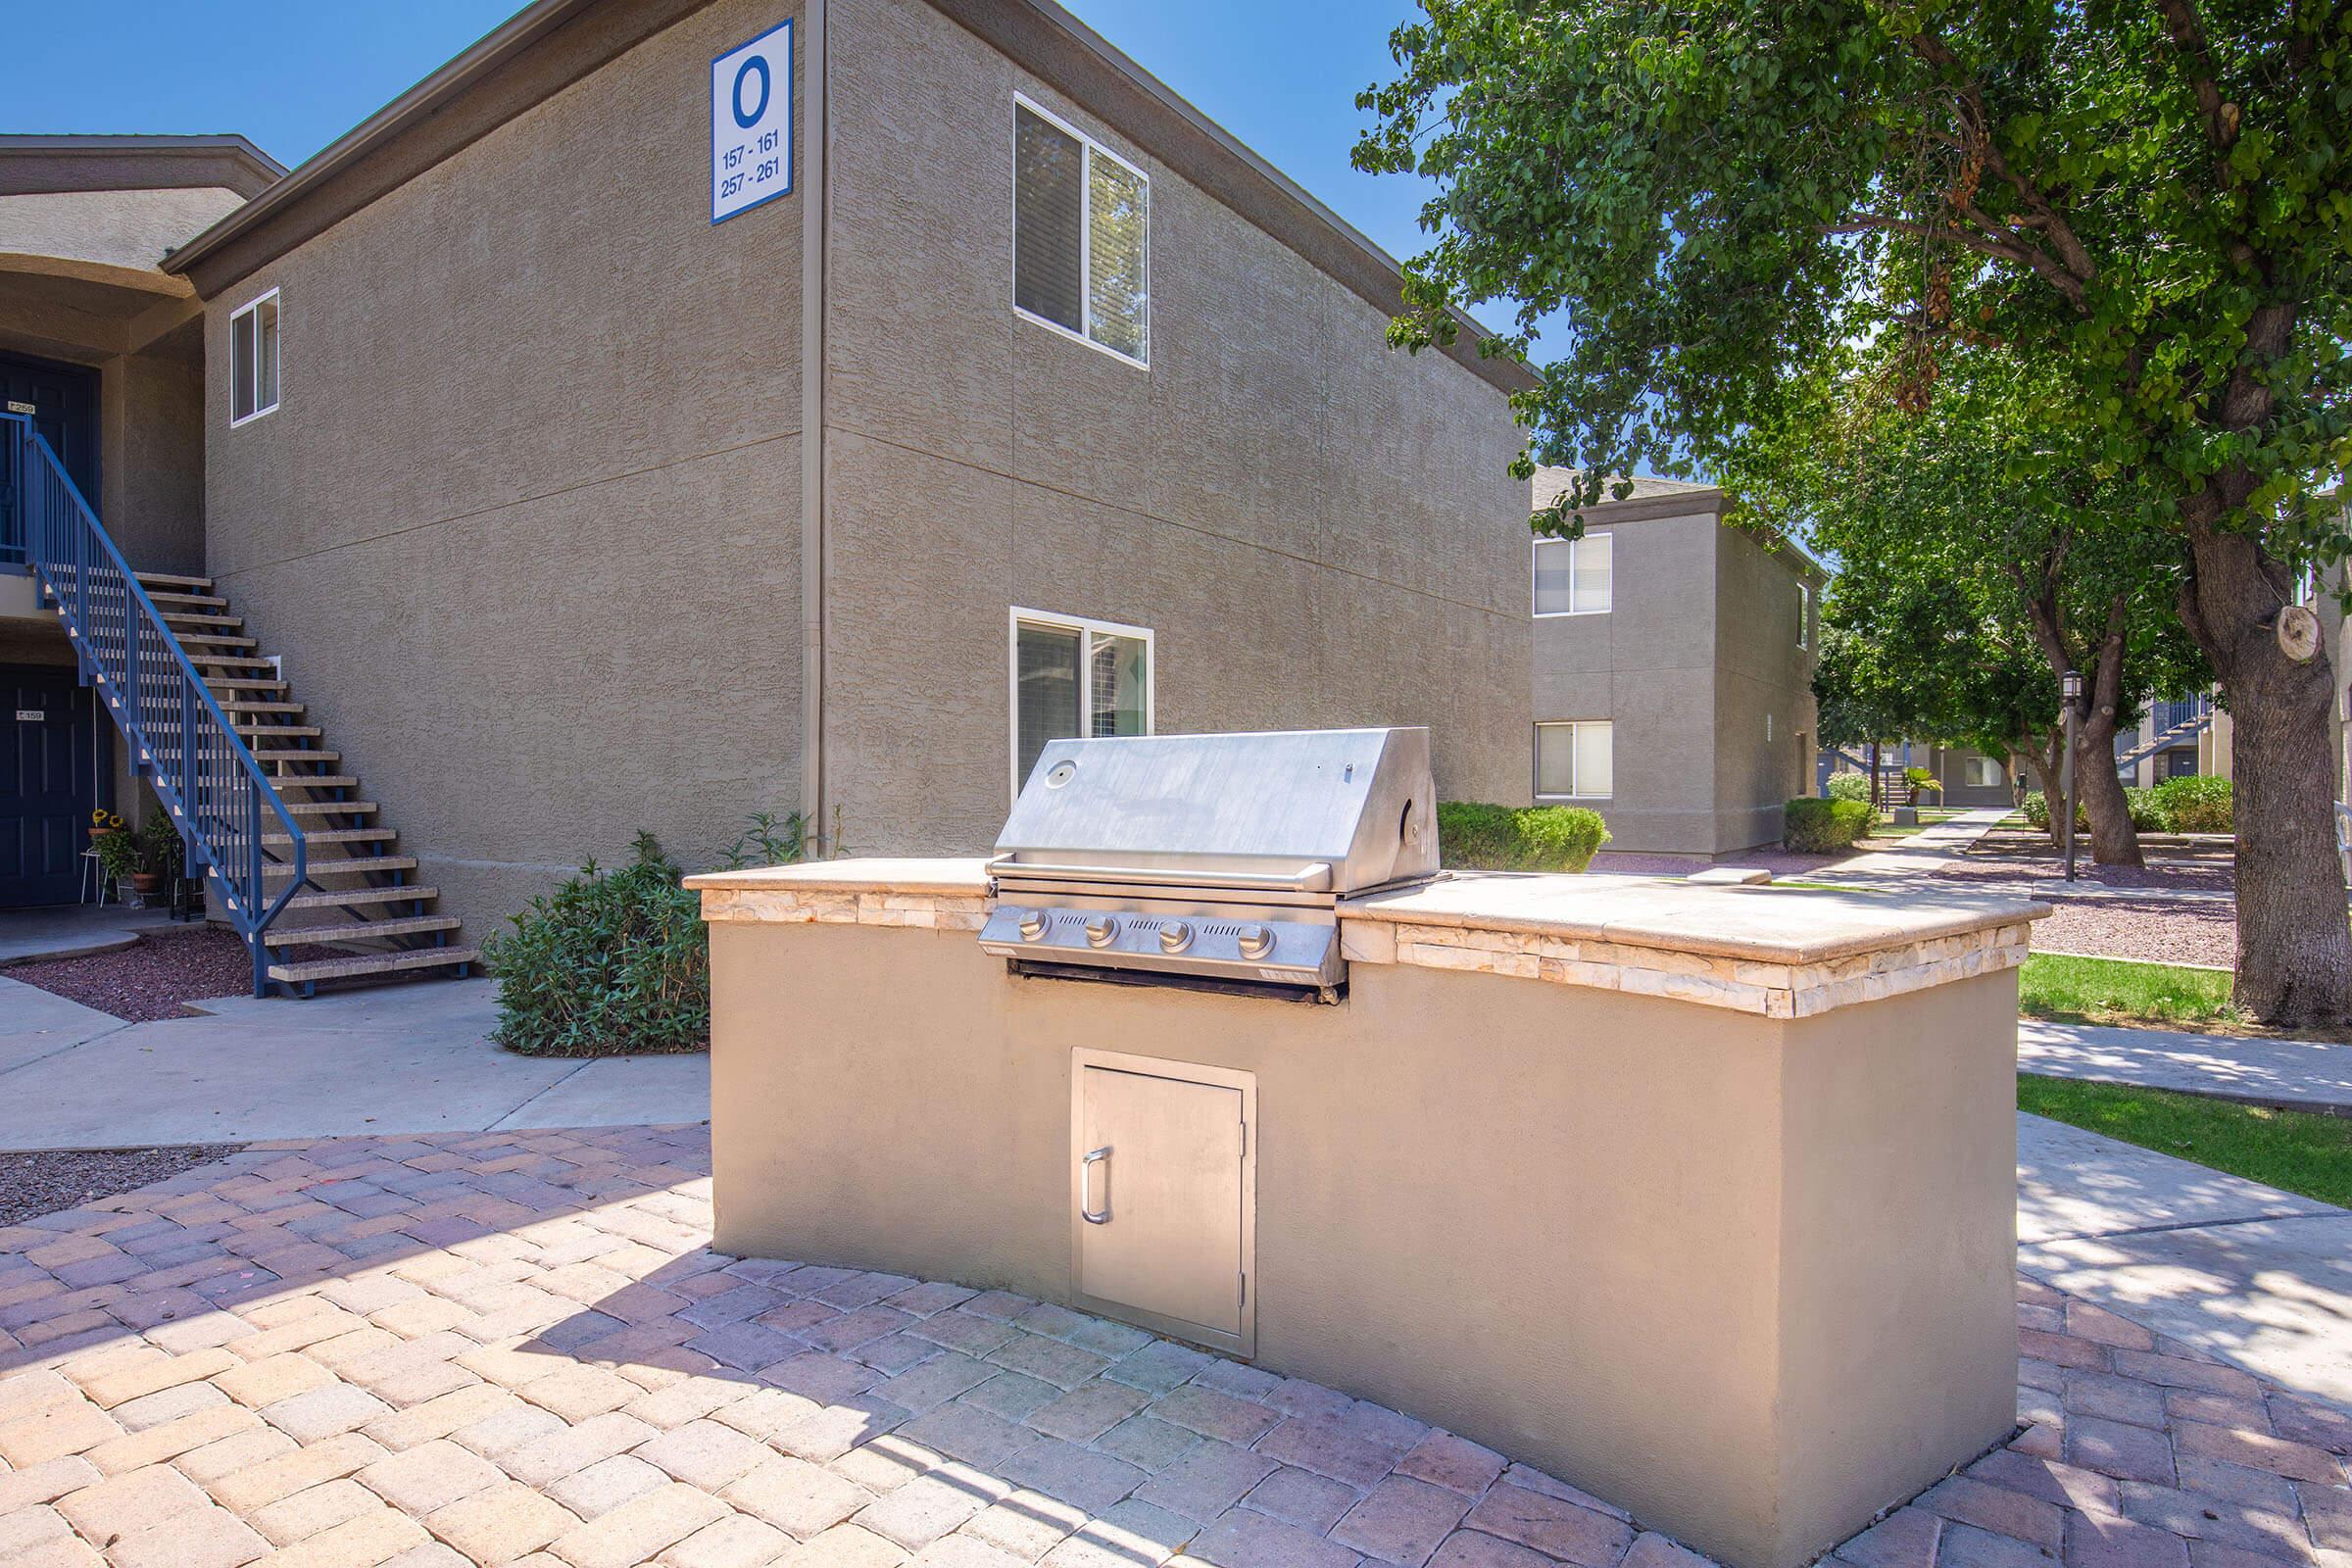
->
[981, 729, 1437, 1002]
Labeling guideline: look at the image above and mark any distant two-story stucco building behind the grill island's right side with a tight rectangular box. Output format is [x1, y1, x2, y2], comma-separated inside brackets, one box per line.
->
[1522, 470, 1823, 856]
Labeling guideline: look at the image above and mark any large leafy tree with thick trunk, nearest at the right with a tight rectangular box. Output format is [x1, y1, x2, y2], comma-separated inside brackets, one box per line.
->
[1357, 0, 2352, 1022]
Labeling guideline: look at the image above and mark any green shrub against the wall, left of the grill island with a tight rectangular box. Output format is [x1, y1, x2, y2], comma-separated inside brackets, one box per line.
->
[482, 832, 710, 1055]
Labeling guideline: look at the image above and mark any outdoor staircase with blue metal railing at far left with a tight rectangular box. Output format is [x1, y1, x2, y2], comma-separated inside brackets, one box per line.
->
[0, 416, 480, 997]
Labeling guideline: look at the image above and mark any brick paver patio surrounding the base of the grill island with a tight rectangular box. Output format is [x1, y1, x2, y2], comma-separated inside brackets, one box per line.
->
[0, 1128, 2352, 1568]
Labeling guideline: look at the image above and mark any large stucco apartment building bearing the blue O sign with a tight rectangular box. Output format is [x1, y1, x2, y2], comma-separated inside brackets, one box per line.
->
[0, 0, 1534, 958]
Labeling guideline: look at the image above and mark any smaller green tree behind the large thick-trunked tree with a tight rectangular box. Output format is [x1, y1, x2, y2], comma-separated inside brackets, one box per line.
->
[1734, 348, 2211, 865]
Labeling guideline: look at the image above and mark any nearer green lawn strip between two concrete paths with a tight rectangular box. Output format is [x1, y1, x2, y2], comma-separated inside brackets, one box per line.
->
[2018, 1072, 2352, 1206]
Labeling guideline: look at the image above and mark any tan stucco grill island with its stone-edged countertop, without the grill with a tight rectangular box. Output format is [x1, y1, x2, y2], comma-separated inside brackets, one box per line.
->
[694, 860, 2046, 1568]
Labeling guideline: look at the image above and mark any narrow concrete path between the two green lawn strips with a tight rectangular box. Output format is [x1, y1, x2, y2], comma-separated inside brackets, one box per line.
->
[2018, 1018, 2352, 1114]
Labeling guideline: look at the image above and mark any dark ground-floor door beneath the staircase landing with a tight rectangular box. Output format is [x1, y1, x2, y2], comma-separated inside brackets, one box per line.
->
[0, 665, 111, 909]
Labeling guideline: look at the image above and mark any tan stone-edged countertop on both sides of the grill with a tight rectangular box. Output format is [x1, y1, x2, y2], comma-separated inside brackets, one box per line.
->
[687, 858, 2051, 1018]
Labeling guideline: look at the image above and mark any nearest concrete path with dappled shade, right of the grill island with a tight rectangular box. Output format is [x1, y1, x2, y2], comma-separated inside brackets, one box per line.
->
[2018, 1114, 2352, 1410]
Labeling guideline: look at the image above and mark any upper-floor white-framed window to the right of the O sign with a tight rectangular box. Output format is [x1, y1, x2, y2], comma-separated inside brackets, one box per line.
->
[1013, 94, 1152, 365]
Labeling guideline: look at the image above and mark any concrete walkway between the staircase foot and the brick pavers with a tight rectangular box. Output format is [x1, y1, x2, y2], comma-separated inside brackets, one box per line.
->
[0, 973, 710, 1150]
